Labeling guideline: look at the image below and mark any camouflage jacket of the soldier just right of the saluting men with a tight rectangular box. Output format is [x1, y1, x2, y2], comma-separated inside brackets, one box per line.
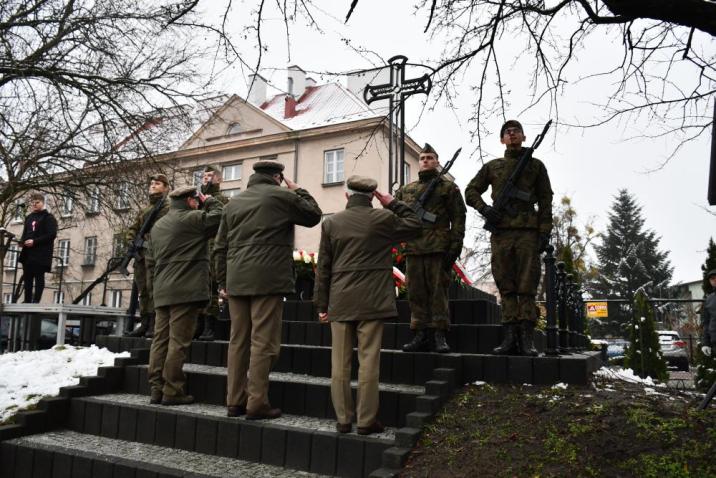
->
[395, 170, 466, 259]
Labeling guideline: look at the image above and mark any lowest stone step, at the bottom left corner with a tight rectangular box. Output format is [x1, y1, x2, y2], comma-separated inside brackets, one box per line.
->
[0, 430, 332, 478]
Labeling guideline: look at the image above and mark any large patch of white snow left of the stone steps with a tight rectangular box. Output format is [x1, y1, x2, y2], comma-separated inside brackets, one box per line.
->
[0, 345, 129, 423]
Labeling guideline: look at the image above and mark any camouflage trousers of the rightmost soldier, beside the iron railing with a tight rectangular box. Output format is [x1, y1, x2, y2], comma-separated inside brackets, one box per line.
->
[490, 229, 541, 323]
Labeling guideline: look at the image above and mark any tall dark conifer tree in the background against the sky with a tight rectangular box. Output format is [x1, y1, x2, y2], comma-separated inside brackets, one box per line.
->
[590, 189, 673, 301]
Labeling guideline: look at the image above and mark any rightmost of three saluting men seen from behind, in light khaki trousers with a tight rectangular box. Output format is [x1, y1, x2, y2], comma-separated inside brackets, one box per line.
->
[315, 176, 421, 435]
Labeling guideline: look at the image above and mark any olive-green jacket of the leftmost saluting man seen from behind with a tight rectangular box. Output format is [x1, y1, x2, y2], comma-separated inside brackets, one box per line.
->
[146, 198, 223, 307]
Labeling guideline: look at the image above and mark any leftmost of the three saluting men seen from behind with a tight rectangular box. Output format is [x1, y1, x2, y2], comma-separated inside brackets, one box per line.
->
[146, 186, 223, 405]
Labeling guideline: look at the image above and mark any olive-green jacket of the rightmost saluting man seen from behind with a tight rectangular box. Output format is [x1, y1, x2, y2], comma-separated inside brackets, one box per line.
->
[314, 194, 421, 321]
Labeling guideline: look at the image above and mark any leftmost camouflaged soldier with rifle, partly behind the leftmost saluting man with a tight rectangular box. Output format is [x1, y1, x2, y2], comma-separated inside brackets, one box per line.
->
[125, 174, 169, 337]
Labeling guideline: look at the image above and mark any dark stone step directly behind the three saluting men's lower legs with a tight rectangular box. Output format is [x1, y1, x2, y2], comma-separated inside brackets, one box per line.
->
[122, 363, 425, 427]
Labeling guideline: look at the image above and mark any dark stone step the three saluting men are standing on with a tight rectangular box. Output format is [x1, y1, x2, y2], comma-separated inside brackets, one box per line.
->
[67, 393, 396, 476]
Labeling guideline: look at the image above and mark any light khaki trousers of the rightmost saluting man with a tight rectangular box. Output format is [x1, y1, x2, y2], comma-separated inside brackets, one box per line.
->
[331, 320, 383, 427]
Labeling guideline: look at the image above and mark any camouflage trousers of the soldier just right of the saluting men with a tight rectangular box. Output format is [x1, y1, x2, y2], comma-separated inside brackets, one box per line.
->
[405, 253, 450, 330]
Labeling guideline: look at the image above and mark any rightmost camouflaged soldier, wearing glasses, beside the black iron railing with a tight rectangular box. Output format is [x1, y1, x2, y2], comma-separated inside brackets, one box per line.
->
[465, 120, 552, 355]
